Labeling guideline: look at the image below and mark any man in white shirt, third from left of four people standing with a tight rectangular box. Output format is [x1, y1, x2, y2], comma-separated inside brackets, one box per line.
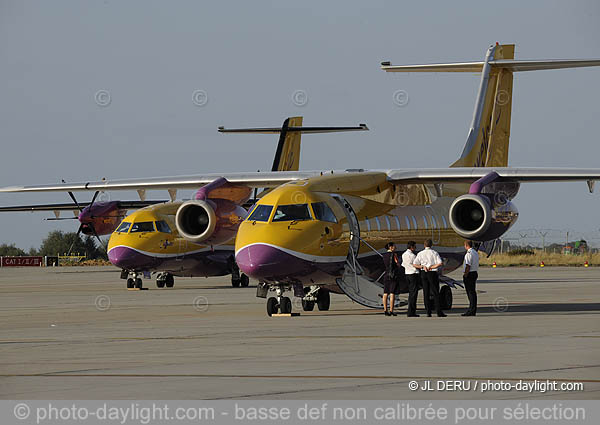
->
[413, 239, 446, 317]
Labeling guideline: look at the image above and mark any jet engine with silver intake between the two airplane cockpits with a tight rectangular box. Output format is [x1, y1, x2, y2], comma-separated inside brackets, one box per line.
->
[175, 199, 247, 245]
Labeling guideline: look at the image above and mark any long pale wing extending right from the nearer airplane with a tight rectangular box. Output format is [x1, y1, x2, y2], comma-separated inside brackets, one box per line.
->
[387, 167, 600, 189]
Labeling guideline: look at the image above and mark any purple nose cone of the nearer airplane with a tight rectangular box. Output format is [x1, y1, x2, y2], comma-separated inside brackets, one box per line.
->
[235, 244, 309, 280]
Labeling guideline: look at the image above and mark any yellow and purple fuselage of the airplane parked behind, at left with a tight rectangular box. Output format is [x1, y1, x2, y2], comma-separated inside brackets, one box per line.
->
[108, 202, 234, 276]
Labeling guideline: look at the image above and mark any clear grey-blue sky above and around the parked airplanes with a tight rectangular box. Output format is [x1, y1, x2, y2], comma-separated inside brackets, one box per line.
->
[0, 0, 600, 248]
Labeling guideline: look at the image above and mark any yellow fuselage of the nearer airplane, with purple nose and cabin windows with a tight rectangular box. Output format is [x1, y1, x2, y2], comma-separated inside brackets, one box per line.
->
[235, 173, 474, 287]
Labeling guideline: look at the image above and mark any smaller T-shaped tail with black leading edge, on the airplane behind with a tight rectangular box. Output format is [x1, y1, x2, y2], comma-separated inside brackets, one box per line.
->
[219, 117, 369, 171]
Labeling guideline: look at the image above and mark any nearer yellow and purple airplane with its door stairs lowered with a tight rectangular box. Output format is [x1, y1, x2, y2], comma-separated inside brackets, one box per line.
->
[0, 44, 600, 315]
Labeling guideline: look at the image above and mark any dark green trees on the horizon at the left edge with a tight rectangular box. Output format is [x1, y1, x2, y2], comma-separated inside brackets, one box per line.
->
[0, 230, 107, 260]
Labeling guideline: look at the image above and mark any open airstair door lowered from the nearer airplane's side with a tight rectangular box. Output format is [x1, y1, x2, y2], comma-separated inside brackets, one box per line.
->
[331, 194, 401, 308]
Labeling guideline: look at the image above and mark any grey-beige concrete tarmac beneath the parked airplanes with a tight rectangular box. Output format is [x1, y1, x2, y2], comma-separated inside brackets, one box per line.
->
[0, 267, 600, 400]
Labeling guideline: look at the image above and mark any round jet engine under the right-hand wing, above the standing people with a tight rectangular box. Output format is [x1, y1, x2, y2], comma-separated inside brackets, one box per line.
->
[449, 194, 519, 242]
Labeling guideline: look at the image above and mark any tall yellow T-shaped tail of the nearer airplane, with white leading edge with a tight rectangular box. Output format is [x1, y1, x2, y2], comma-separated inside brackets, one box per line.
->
[381, 43, 600, 167]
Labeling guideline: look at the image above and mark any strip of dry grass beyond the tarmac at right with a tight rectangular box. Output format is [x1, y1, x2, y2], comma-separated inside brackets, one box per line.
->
[479, 251, 600, 267]
